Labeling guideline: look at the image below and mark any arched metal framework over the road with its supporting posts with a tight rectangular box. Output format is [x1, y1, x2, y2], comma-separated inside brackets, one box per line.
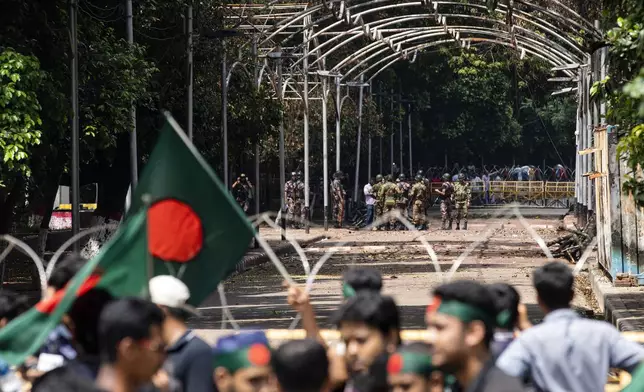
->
[224, 0, 606, 227]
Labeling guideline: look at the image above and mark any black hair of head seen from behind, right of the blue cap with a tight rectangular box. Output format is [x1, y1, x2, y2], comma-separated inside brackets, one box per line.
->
[271, 339, 329, 392]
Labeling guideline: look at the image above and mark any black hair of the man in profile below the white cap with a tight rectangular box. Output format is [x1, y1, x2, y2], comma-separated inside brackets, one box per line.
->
[98, 297, 164, 363]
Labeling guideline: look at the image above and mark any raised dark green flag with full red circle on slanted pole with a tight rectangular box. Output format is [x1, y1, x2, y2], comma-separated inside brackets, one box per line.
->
[128, 113, 254, 306]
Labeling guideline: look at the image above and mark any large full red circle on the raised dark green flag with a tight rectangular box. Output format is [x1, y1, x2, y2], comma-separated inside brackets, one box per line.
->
[148, 199, 203, 263]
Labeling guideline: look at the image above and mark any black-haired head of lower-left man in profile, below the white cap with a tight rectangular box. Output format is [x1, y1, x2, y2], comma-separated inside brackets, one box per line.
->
[98, 298, 165, 384]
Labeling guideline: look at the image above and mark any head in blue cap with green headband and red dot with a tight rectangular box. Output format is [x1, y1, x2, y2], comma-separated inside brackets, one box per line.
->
[213, 332, 272, 392]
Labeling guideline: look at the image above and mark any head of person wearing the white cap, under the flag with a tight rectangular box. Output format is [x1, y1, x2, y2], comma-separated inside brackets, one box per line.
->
[149, 275, 199, 328]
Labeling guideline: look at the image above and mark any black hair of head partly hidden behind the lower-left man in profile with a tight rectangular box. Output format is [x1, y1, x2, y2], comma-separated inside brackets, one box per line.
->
[67, 288, 114, 355]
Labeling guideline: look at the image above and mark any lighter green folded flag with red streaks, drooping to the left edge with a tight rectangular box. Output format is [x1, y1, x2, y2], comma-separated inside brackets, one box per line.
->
[0, 212, 148, 365]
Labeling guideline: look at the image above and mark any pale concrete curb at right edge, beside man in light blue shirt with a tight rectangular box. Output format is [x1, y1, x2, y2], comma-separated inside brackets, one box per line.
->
[589, 264, 644, 332]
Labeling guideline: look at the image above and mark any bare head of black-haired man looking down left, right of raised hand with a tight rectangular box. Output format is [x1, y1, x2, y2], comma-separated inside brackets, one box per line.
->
[333, 291, 400, 374]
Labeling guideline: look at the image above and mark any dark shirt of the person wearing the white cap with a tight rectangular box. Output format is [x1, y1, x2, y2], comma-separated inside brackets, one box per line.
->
[164, 331, 215, 392]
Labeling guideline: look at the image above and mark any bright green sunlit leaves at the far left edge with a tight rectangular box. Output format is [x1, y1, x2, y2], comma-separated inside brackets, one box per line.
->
[0, 49, 42, 185]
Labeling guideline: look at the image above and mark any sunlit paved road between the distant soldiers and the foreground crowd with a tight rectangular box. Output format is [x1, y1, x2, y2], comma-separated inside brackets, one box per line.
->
[192, 219, 591, 329]
